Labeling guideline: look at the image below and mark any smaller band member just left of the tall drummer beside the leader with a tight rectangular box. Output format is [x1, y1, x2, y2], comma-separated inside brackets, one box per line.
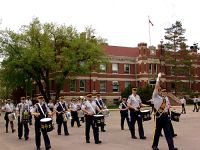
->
[119, 98, 130, 130]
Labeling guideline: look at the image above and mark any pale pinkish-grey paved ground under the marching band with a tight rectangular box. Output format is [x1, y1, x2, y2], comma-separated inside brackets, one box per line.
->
[0, 106, 200, 150]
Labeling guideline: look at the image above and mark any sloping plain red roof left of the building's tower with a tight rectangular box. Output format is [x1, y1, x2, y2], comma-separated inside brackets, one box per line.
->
[105, 45, 139, 57]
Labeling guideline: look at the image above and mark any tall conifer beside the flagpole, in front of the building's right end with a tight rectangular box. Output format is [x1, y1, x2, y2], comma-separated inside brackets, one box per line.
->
[164, 21, 187, 95]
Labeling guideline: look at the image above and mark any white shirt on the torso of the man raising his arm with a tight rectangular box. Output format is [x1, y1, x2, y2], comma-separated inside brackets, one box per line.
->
[152, 91, 170, 112]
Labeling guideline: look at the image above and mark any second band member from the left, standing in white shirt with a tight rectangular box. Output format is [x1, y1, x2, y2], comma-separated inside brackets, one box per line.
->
[16, 97, 30, 140]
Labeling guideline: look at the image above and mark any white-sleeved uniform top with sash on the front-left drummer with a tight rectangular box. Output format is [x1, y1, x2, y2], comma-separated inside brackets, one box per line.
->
[31, 102, 51, 119]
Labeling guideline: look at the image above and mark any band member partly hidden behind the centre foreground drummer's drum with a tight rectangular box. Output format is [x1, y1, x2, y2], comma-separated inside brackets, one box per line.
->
[95, 93, 107, 132]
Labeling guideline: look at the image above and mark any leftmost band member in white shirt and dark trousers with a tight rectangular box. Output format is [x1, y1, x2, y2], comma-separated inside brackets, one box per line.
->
[2, 99, 15, 133]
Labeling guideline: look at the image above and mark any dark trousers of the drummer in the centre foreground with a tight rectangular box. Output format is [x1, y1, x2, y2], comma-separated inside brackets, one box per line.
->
[85, 115, 99, 143]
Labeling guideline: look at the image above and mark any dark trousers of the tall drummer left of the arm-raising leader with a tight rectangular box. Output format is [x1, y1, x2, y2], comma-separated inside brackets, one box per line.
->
[130, 110, 144, 138]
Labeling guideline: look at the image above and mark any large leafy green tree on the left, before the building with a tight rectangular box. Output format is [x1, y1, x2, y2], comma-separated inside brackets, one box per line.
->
[0, 18, 107, 101]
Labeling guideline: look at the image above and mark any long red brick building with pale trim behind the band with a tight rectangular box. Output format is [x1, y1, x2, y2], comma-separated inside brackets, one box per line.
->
[48, 43, 200, 103]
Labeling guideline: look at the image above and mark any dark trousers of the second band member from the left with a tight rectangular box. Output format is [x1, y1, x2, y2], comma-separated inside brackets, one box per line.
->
[18, 117, 29, 139]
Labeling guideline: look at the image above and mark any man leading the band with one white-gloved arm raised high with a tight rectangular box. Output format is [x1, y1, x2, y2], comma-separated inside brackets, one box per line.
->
[152, 73, 178, 150]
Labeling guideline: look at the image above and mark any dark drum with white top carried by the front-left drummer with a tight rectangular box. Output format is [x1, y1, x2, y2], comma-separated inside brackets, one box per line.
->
[40, 118, 54, 132]
